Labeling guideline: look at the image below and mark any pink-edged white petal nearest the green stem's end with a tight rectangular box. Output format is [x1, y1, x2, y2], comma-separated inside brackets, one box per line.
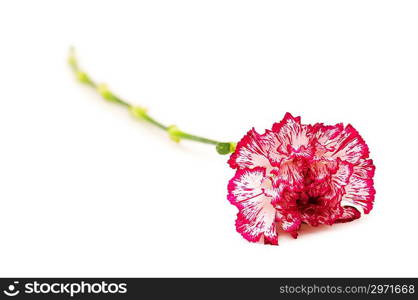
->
[228, 128, 271, 169]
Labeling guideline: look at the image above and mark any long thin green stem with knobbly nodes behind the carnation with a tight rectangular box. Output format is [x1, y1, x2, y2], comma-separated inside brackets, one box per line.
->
[68, 48, 236, 154]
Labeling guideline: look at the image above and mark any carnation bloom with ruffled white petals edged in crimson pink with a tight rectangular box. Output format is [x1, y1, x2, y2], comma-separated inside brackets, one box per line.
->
[228, 113, 375, 245]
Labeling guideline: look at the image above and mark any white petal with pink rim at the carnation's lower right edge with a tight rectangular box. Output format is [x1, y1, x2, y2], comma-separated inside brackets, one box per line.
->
[341, 174, 376, 214]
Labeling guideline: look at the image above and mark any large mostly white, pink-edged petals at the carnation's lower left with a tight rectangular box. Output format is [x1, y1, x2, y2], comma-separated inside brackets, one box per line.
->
[228, 167, 277, 245]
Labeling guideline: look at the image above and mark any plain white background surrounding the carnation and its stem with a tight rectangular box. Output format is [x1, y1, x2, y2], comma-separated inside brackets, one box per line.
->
[0, 0, 418, 276]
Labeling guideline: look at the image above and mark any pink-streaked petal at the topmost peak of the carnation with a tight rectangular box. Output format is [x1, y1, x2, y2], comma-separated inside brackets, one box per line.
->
[270, 113, 314, 162]
